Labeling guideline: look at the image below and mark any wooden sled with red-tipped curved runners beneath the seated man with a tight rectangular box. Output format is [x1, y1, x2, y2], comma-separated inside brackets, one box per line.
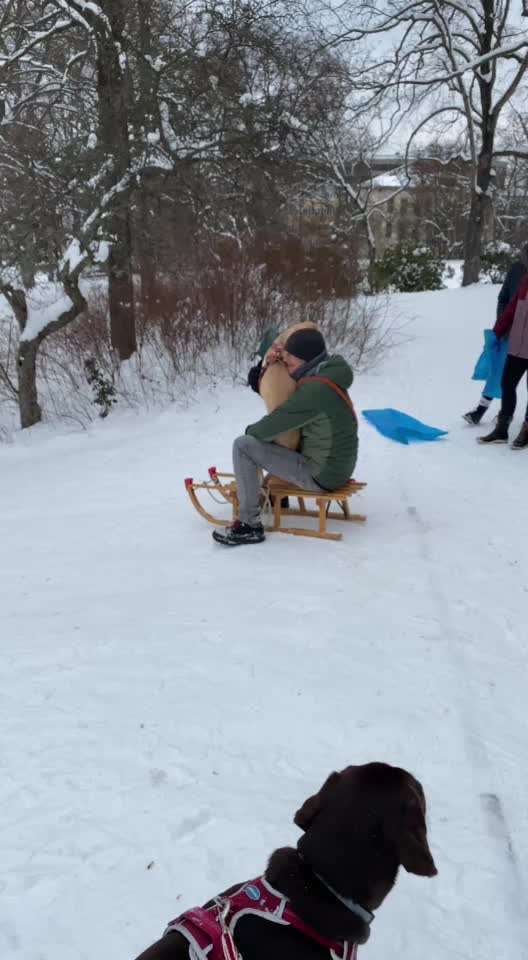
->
[185, 467, 367, 540]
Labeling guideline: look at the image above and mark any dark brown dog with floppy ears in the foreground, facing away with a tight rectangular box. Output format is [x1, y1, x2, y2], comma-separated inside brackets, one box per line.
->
[133, 763, 437, 960]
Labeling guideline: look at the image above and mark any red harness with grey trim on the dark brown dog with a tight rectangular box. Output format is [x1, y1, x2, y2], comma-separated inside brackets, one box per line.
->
[165, 877, 357, 960]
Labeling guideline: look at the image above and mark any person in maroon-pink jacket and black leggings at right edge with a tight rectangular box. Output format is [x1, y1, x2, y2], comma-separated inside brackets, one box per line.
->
[479, 276, 528, 450]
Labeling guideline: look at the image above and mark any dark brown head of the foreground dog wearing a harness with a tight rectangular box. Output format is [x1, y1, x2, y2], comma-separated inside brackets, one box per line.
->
[295, 763, 437, 904]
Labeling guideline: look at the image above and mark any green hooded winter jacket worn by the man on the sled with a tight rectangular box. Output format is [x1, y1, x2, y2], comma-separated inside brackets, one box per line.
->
[246, 356, 358, 490]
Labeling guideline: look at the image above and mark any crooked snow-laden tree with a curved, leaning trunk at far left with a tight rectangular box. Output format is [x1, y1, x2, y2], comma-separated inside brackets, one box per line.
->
[0, 0, 147, 427]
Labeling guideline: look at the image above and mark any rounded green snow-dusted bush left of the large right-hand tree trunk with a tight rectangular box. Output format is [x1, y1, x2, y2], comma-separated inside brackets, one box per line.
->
[374, 244, 445, 293]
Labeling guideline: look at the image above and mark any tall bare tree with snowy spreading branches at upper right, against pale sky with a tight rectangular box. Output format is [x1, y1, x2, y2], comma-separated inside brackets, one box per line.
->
[318, 0, 528, 284]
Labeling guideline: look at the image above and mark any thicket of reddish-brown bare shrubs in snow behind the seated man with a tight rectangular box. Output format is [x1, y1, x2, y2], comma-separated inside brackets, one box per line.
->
[0, 248, 401, 442]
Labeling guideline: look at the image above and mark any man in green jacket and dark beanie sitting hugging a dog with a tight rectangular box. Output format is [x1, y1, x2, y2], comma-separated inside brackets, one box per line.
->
[213, 329, 358, 546]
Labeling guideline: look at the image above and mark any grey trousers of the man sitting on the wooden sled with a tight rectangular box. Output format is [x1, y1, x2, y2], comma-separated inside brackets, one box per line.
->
[233, 436, 317, 524]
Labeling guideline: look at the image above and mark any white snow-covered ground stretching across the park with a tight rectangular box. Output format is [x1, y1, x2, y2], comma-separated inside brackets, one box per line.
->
[0, 286, 528, 960]
